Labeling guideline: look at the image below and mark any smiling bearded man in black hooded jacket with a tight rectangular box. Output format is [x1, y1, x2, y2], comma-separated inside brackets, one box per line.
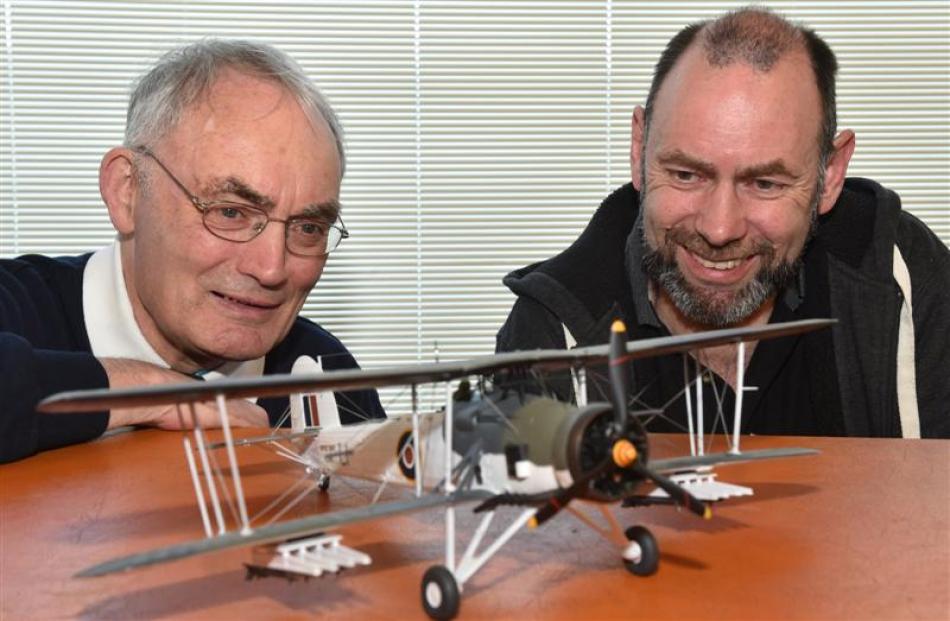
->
[497, 8, 950, 437]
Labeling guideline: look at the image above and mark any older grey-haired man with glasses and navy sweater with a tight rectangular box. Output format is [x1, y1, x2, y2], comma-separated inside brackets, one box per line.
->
[0, 40, 383, 461]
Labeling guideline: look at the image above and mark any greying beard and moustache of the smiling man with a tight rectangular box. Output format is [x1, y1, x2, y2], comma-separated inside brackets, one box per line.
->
[639, 197, 820, 328]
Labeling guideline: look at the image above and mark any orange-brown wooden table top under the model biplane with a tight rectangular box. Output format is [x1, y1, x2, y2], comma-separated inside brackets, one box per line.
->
[0, 431, 950, 621]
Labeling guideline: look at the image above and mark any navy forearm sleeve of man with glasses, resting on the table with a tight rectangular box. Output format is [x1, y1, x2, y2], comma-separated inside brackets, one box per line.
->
[0, 332, 109, 463]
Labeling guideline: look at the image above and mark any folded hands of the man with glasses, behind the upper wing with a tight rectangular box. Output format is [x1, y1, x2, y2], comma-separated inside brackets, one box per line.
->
[99, 358, 268, 429]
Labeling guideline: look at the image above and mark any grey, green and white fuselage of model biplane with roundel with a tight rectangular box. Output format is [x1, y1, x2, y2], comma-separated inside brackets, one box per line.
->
[305, 391, 652, 494]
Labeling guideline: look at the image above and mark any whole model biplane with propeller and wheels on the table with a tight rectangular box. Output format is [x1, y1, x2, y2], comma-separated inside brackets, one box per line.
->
[39, 319, 834, 619]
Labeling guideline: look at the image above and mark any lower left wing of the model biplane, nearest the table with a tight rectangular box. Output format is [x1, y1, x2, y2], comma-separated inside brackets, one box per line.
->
[76, 490, 491, 578]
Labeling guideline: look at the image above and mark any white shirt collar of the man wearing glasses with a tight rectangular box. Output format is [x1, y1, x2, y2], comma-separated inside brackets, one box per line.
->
[82, 243, 264, 380]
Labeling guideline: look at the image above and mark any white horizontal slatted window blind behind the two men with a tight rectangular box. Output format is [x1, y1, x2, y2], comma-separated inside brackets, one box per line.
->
[0, 0, 950, 411]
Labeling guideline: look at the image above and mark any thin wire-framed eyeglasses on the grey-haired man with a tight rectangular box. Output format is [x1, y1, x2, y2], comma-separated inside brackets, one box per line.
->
[135, 147, 350, 257]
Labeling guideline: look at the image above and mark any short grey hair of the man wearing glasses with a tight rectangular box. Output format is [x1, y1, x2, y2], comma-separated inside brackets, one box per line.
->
[125, 39, 346, 177]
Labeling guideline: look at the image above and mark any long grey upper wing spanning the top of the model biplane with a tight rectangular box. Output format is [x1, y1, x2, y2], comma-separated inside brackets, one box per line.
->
[37, 319, 835, 413]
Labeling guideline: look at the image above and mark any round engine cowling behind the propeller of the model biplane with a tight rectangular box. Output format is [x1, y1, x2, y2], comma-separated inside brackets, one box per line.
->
[554, 403, 649, 502]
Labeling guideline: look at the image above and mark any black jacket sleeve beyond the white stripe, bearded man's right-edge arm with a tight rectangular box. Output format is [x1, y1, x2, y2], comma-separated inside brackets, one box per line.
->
[898, 213, 950, 438]
